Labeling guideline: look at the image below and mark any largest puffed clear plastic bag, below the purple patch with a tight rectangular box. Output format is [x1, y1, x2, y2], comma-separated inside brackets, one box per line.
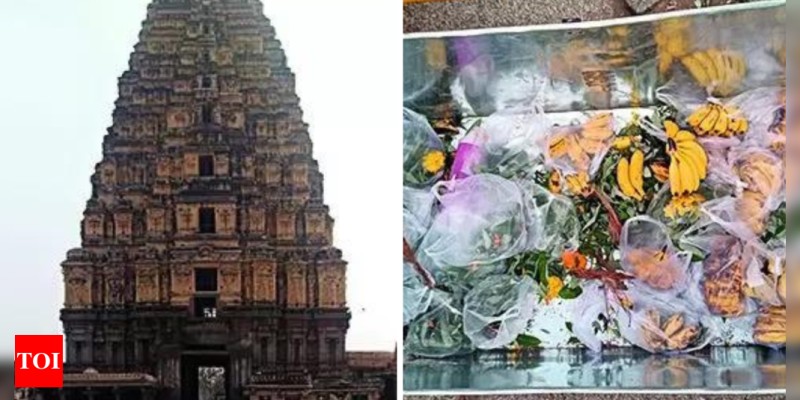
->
[417, 174, 528, 270]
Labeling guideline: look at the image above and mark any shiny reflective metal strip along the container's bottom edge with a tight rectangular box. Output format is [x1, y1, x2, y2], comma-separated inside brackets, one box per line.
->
[403, 347, 786, 392]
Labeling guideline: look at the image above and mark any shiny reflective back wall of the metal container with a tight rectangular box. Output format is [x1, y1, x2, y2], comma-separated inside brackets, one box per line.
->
[404, 1, 786, 116]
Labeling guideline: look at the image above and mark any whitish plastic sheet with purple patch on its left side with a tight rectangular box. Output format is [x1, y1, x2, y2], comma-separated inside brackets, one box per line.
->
[451, 107, 552, 179]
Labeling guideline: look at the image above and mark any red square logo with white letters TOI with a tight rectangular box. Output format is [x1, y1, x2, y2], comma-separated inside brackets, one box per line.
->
[14, 335, 64, 388]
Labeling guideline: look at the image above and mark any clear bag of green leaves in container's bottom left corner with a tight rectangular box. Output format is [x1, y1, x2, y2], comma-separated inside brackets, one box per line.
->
[404, 291, 472, 358]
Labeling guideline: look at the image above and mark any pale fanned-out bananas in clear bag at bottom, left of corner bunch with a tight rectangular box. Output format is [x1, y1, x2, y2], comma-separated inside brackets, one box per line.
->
[641, 310, 700, 352]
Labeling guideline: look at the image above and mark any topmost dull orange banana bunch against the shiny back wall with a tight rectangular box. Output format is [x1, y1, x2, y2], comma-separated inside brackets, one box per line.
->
[681, 48, 747, 97]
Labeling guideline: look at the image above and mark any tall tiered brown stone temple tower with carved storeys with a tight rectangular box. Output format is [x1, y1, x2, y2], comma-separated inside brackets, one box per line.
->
[30, 0, 396, 400]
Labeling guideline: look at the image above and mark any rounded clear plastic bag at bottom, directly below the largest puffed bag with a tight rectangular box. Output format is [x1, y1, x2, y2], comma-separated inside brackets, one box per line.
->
[464, 275, 538, 350]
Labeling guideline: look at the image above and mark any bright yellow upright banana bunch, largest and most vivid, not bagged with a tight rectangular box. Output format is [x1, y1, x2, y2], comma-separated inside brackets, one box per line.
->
[664, 120, 708, 195]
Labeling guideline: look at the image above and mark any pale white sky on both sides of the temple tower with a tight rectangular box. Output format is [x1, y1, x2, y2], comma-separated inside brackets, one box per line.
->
[0, 0, 402, 358]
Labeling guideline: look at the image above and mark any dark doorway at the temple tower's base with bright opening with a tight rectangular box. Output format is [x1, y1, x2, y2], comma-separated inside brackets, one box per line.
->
[181, 351, 231, 400]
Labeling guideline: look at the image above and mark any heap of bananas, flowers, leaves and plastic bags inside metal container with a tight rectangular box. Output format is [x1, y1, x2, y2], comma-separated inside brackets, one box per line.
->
[404, 14, 786, 357]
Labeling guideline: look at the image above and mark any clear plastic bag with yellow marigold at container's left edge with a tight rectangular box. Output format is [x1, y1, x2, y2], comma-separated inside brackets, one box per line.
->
[403, 108, 445, 188]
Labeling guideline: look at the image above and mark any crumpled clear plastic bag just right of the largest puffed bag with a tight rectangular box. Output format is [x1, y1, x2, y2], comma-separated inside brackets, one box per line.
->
[517, 180, 581, 257]
